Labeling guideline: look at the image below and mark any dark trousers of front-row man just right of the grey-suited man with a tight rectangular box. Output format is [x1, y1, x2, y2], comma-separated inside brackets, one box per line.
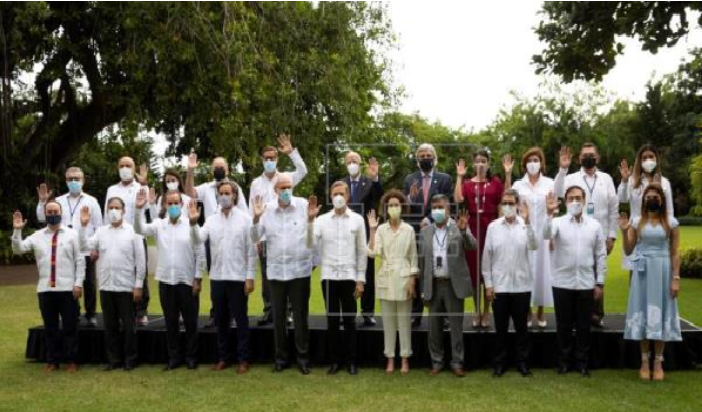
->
[492, 292, 531, 366]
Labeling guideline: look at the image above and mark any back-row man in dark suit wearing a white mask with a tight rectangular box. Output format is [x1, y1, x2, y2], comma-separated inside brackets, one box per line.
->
[343, 152, 383, 326]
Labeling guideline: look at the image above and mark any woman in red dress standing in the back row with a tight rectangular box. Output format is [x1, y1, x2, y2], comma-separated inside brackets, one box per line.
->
[453, 150, 513, 328]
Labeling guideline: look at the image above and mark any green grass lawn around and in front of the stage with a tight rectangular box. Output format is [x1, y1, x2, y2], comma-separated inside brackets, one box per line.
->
[0, 227, 702, 412]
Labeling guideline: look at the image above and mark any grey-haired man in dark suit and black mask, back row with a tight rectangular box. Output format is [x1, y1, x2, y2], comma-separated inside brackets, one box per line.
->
[403, 143, 453, 327]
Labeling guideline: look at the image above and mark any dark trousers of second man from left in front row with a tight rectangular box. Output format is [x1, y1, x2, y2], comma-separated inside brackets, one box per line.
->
[100, 291, 137, 366]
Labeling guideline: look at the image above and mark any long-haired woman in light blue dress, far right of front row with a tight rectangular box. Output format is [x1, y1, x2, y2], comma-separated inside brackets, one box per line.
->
[619, 183, 682, 380]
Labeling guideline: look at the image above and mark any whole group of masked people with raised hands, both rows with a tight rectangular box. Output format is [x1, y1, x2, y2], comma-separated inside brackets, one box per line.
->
[12, 135, 681, 380]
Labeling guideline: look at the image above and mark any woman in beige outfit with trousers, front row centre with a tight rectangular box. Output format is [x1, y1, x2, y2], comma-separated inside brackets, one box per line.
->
[368, 189, 419, 375]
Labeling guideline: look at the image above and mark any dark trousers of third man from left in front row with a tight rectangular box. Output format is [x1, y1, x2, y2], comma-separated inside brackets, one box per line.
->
[158, 282, 197, 363]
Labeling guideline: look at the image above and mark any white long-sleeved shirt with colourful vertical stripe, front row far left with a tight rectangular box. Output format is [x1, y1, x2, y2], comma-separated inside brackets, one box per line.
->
[12, 226, 85, 293]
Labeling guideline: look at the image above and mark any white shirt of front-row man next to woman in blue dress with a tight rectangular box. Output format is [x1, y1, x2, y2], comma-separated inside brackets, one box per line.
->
[544, 213, 607, 290]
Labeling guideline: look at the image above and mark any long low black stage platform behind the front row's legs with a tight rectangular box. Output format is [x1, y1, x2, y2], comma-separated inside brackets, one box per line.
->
[26, 314, 702, 369]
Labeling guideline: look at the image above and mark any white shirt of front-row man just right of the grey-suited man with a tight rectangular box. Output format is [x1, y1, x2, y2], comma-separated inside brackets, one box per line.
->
[482, 216, 538, 293]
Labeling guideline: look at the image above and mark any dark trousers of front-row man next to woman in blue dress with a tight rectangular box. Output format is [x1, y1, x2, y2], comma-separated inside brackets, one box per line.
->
[553, 287, 593, 368]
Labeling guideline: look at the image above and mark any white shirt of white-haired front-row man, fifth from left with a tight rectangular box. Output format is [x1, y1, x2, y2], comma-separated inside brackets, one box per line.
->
[251, 197, 312, 281]
